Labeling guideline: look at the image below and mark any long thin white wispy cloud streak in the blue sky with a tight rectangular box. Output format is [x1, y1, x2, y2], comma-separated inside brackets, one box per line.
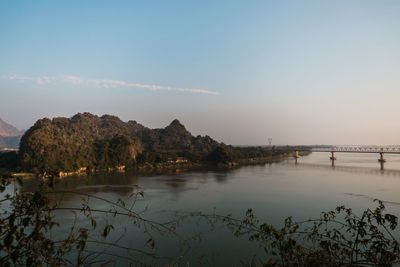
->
[1, 75, 220, 95]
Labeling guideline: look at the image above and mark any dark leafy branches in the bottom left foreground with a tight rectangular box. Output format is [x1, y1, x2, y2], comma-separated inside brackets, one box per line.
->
[0, 173, 184, 266]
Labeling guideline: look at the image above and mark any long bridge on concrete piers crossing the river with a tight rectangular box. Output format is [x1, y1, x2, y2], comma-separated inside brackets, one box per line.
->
[295, 145, 400, 169]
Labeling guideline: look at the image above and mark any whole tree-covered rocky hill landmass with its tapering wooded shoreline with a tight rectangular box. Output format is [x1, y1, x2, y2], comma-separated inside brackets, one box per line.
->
[13, 113, 310, 174]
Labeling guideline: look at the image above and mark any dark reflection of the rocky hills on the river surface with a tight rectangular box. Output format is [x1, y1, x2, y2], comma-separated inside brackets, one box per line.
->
[19, 169, 241, 202]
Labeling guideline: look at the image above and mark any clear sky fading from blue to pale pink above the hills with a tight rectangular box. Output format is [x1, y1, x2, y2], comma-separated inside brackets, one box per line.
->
[0, 0, 400, 145]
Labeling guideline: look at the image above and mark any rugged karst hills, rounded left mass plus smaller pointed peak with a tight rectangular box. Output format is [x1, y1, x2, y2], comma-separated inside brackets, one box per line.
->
[20, 113, 219, 172]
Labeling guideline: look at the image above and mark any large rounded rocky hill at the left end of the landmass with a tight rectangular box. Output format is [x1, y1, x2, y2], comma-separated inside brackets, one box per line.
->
[19, 113, 141, 173]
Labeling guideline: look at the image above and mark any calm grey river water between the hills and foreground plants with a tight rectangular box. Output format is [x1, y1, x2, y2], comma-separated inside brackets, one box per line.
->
[18, 153, 400, 266]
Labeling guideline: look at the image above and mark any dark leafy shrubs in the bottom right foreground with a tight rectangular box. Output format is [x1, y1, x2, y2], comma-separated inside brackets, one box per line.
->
[181, 200, 400, 266]
